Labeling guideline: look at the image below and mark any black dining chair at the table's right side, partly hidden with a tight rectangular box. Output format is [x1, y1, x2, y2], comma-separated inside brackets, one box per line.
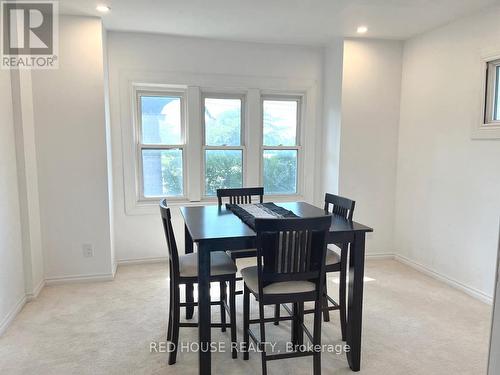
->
[274, 193, 356, 341]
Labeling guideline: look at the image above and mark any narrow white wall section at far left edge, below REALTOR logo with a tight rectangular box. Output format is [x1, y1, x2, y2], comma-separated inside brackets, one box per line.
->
[0, 70, 25, 335]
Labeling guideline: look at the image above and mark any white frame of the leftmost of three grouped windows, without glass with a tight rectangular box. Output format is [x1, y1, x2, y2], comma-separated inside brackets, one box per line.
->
[134, 87, 188, 202]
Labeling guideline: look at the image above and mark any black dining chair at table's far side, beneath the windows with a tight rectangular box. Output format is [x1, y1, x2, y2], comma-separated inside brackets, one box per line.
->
[217, 187, 264, 262]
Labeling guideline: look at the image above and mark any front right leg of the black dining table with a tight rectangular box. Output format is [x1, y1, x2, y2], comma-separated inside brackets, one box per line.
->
[347, 233, 365, 371]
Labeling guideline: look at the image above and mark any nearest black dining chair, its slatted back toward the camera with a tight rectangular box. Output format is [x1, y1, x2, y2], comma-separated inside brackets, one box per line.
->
[241, 215, 331, 375]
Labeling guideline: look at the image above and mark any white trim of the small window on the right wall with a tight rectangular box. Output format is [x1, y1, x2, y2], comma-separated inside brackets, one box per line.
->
[472, 52, 500, 139]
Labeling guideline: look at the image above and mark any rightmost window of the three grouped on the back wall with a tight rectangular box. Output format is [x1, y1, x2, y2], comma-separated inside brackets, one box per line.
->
[262, 97, 301, 195]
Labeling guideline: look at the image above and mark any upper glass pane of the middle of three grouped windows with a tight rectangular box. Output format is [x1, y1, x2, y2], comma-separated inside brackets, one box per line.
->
[205, 98, 241, 146]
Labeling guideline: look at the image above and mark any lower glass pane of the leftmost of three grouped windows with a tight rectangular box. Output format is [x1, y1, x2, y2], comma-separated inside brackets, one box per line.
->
[142, 149, 183, 197]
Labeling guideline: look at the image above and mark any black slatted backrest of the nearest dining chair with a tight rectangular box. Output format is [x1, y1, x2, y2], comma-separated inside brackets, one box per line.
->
[255, 215, 332, 295]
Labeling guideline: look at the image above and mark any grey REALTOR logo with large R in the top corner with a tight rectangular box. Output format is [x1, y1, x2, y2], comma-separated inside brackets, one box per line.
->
[1, 1, 58, 69]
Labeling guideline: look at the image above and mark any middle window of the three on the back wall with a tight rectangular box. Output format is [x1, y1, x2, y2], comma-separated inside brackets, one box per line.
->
[203, 95, 244, 196]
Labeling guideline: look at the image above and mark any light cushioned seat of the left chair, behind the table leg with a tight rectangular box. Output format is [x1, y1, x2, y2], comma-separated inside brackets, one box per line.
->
[179, 251, 237, 277]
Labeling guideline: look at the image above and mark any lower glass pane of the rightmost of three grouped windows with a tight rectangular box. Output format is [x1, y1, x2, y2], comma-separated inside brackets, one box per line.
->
[263, 150, 297, 194]
